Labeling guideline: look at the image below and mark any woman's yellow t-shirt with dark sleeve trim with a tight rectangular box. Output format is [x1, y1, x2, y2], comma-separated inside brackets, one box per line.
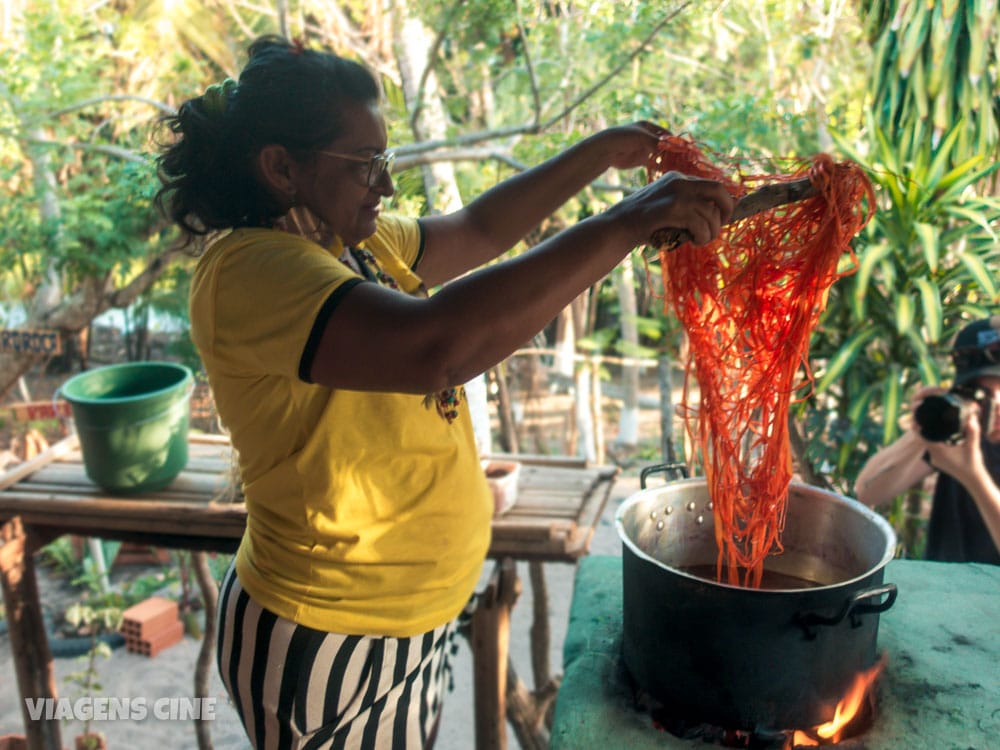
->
[191, 217, 493, 637]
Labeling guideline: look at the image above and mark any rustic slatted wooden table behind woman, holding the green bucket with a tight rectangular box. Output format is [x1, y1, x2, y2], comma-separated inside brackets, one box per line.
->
[0, 434, 617, 750]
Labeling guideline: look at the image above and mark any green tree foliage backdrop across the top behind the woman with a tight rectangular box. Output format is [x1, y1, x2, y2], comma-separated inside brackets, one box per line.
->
[0, 0, 1000, 528]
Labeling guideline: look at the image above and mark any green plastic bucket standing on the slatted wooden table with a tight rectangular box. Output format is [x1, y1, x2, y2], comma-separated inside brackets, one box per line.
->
[59, 362, 194, 493]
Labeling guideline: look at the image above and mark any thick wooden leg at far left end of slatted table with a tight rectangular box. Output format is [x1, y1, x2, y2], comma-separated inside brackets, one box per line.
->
[0, 517, 62, 750]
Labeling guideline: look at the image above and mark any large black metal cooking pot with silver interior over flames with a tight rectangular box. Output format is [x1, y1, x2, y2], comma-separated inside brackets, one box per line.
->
[616, 479, 896, 731]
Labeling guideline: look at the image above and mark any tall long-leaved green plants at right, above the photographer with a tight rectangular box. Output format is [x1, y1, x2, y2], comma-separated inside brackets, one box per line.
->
[801, 0, 1000, 548]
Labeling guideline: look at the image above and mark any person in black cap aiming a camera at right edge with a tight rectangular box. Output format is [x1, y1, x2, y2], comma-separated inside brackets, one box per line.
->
[855, 316, 1000, 565]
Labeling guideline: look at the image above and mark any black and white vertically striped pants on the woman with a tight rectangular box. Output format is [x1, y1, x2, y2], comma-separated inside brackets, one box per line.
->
[216, 566, 456, 750]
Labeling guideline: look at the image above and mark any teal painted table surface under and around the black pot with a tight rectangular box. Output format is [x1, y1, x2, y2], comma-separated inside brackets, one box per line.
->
[550, 556, 1000, 750]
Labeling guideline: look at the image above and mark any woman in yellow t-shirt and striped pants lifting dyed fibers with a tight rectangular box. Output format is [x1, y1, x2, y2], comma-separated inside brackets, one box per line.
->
[158, 37, 732, 748]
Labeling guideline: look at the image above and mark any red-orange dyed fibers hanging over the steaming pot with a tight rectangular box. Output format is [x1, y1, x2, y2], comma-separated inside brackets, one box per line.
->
[649, 135, 875, 587]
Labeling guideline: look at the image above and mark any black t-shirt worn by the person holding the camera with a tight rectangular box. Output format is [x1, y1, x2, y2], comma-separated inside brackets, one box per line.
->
[924, 440, 1000, 565]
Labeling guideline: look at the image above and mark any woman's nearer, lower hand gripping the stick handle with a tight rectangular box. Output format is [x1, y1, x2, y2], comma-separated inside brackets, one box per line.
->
[609, 172, 735, 247]
